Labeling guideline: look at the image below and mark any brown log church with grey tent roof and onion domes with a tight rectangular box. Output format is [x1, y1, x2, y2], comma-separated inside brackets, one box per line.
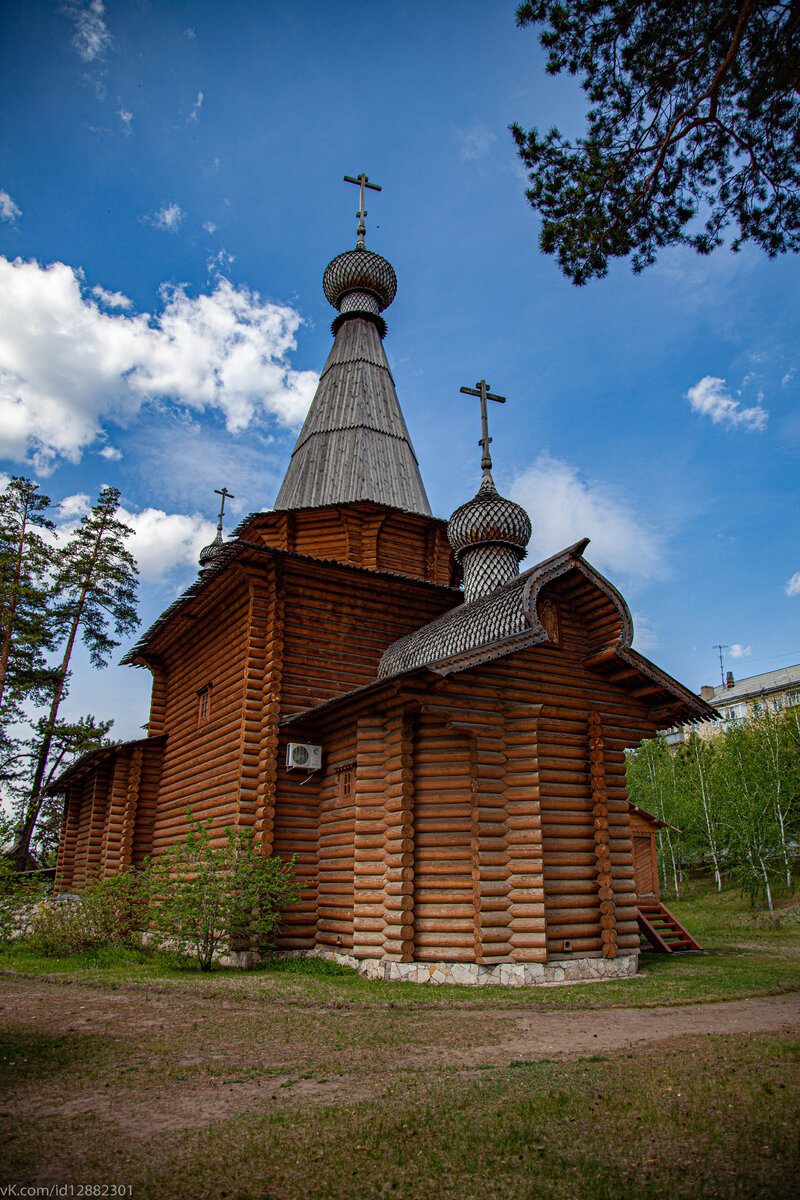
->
[53, 176, 711, 984]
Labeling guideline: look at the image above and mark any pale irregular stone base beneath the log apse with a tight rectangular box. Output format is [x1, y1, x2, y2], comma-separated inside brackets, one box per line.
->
[278, 948, 639, 988]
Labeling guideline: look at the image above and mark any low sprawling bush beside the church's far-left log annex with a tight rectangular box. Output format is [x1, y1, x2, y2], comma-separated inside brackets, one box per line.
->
[26, 871, 150, 956]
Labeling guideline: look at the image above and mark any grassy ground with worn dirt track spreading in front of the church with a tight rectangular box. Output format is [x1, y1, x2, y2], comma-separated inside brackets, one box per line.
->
[0, 887, 800, 1200]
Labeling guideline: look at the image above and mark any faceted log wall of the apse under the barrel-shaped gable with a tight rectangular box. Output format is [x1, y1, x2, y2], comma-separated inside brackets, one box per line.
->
[275, 572, 654, 964]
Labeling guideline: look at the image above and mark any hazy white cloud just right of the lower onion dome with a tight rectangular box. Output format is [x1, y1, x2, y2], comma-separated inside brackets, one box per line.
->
[511, 454, 668, 578]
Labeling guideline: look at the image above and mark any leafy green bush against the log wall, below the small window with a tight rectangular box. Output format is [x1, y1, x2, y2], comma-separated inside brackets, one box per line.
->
[146, 810, 300, 971]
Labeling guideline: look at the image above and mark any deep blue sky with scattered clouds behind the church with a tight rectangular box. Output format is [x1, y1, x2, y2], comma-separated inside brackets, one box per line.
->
[0, 0, 800, 737]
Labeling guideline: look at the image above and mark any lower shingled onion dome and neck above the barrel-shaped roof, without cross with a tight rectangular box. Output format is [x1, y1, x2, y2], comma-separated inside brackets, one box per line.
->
[447, 470, 533, 604]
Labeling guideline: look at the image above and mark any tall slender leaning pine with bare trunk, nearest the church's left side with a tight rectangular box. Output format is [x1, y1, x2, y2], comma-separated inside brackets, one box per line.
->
[12, 487, 138, 863]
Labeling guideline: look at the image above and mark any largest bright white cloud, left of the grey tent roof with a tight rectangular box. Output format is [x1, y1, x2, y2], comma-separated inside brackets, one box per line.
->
[0, 256, 318, 474]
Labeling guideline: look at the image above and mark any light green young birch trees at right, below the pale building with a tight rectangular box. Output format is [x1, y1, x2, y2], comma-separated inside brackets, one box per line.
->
[627, 709, 800, 911]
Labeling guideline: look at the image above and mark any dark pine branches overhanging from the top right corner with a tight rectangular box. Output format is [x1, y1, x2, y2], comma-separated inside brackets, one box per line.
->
[511, 0, 800, 284]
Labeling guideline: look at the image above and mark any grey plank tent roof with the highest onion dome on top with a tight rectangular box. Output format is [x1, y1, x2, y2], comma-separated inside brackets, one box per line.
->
[275, 250, 431, 516]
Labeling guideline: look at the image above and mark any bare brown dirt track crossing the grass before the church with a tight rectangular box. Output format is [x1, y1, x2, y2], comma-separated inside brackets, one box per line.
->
[0, 976, 800, 1141]
